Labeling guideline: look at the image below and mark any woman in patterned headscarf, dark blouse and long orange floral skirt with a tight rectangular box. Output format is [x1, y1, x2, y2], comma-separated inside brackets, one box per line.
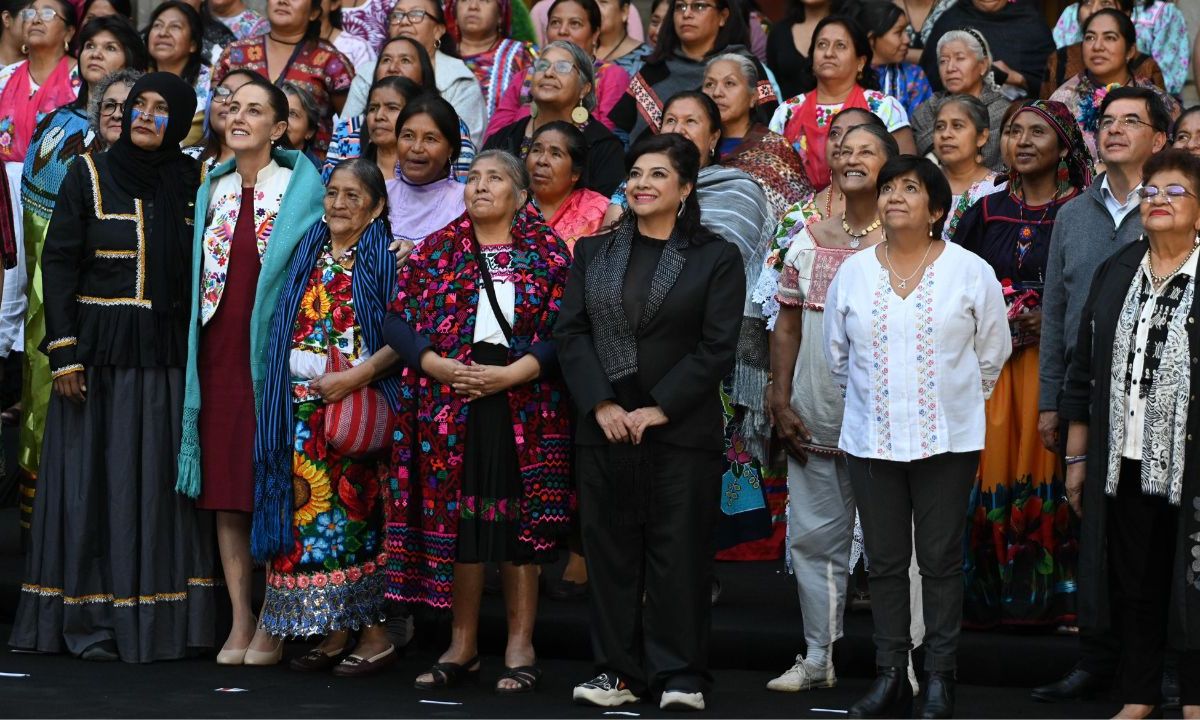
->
[954, 97, 1096, 626]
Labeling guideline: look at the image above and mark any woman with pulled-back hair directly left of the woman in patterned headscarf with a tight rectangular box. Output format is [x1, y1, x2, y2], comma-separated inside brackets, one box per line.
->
[934, 95, 1006, 241]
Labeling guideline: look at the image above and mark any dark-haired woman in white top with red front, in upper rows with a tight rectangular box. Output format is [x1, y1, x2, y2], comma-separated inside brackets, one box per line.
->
[770, 16, 913, 190]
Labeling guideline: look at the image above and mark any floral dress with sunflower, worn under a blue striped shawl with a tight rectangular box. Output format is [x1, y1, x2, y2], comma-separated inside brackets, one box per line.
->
[263, 244, 388, 636]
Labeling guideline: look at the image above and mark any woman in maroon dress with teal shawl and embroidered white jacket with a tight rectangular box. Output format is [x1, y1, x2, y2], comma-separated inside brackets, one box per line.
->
[178, 78, 324, 665]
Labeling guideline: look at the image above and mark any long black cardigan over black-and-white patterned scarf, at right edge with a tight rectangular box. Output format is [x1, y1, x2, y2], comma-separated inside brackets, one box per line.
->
[1058, 240, 1200, 650]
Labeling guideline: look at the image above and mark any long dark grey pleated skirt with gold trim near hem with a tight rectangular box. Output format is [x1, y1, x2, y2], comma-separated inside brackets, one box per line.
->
[10, 367, 216, 662]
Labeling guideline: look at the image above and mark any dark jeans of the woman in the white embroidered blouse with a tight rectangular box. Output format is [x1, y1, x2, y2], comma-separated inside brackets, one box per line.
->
[848, 451, 979, 672]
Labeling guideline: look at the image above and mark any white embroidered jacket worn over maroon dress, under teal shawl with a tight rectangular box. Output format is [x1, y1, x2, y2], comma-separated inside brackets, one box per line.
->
[200, 160, 292, 324]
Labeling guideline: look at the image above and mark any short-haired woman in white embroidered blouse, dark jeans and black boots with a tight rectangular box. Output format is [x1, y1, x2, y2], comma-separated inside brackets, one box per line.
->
[824, 155, 1012, 718]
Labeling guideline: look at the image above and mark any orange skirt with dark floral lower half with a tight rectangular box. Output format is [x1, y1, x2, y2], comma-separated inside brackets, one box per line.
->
[962, 346, 1079, 628]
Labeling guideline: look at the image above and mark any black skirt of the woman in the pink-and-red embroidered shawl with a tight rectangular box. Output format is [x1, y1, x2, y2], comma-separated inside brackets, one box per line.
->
[457, 342, 558, 565]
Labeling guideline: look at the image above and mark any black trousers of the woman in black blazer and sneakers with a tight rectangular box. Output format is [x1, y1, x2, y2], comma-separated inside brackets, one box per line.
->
[576, 444, 724, 696]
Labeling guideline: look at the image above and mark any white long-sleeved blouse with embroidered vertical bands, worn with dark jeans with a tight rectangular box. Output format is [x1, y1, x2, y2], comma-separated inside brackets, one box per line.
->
[824, 242, 1013, 462]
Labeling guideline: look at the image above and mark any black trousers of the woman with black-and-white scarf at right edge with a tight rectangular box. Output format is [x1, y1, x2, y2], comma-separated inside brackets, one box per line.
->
[1108, 460, 1200, 704]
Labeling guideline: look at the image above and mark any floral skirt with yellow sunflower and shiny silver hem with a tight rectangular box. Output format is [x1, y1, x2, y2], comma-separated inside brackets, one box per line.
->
[262, 401, 388, 637]
